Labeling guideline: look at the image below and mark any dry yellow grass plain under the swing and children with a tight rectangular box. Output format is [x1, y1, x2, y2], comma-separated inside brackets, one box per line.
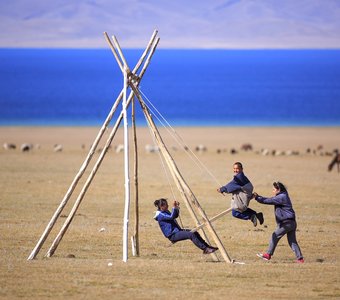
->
[0, 127, 340, 299]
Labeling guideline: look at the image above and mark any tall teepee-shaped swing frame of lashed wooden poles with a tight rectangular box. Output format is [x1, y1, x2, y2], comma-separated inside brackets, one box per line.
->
[28, 30, 234, 263]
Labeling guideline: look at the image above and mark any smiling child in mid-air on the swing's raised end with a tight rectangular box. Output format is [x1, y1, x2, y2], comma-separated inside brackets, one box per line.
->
[217, 162, 264, 227]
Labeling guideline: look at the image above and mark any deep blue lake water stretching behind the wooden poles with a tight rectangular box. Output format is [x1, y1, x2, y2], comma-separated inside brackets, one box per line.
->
[0, 49, 340, 126]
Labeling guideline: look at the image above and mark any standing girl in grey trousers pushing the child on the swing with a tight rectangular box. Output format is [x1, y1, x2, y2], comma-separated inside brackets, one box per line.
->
[253, 182, 304, 263]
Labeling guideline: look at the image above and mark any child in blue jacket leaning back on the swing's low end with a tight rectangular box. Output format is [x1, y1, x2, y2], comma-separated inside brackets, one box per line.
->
[154, 198, 218, 254]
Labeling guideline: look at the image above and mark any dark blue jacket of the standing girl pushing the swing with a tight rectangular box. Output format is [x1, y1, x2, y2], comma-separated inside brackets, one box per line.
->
[255, 192, 295, 224]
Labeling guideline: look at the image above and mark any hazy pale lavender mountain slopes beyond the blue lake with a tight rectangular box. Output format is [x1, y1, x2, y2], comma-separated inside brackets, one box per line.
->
[0, 0, 340, 49]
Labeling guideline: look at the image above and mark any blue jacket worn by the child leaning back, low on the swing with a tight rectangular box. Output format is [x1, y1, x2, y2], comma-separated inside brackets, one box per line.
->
[154, 207, 182, 238]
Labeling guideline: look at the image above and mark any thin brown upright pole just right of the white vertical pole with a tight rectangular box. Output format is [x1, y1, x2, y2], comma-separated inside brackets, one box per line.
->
[132, 99, 139, 256]
